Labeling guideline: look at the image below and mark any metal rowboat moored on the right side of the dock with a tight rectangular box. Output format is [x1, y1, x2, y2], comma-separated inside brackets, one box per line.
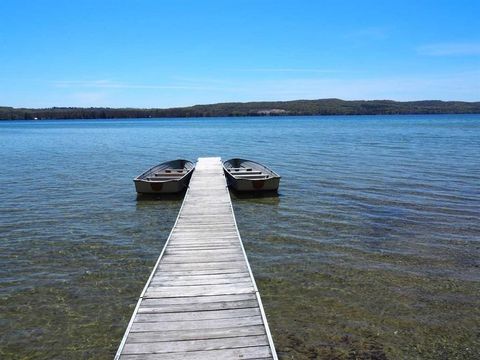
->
[223, 159, 280, 192]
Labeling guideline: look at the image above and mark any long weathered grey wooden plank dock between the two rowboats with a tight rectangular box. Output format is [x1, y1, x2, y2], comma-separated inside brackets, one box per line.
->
[115, 158, 278, 360]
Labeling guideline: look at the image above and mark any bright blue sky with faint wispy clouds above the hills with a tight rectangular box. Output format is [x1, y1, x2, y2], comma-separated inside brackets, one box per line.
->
[0, 0, 480, 107]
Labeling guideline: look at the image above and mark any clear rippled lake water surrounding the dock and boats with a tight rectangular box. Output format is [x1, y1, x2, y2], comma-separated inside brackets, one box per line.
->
[0, 115, 480, 359]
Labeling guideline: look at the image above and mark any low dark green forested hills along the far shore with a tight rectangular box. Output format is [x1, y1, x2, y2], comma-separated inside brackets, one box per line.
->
[0, 99, 480, 120]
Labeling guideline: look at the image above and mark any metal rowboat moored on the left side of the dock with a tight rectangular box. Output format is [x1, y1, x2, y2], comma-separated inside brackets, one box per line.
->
[133, 159, 195, 194]
